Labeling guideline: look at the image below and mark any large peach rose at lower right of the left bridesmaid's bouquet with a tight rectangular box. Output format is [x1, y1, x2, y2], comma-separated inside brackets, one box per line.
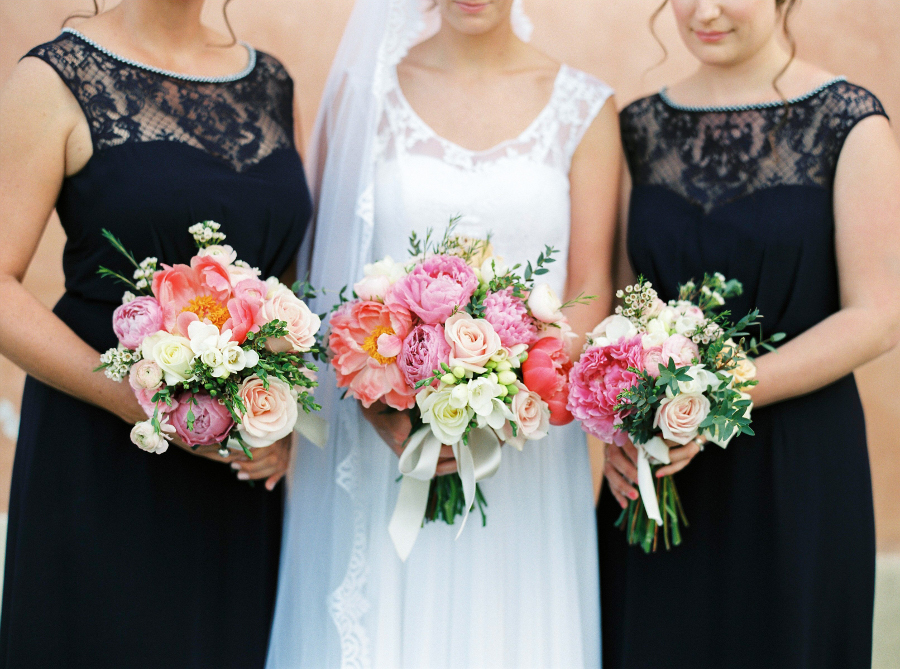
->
[238, 374, 298, 448]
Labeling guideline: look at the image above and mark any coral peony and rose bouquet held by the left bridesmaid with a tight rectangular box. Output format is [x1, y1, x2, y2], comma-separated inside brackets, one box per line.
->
[97, 221, 320, 458]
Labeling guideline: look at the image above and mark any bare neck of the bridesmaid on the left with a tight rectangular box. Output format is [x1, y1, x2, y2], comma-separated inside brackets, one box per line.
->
[111, 0, 206, 51]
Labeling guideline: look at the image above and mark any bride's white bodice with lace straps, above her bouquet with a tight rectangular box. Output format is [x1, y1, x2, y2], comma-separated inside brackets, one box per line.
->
[373, 65, 612, 295]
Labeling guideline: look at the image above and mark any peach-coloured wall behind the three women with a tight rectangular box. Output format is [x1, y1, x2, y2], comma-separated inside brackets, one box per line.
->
[0, 0, 900, 551]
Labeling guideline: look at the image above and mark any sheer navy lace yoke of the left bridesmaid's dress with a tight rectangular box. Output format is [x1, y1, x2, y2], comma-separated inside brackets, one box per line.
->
[27, 28, 294, 171]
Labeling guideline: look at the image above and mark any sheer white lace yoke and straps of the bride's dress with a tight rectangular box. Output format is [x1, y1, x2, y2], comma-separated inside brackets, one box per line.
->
[378, 65, 612, 172]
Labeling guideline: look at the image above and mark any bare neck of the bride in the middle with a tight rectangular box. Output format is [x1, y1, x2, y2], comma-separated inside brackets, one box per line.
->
[434, 21, 519, 74]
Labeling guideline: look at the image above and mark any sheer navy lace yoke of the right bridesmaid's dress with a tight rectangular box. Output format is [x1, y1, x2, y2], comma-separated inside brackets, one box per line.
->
[621, 79, 886, 212]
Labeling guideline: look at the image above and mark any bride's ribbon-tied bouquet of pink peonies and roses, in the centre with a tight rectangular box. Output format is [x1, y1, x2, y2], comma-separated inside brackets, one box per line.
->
[328, 223, 572, 560]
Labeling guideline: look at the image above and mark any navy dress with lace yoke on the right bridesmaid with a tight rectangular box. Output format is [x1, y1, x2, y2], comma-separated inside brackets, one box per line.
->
[597, 79, 884, 669]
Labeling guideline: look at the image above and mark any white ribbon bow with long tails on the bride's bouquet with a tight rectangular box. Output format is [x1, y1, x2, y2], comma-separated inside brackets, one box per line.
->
[388, 426, 501, 562]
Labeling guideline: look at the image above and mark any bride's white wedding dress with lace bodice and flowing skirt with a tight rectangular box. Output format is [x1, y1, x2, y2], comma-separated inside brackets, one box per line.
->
[268, 2, 612, 669]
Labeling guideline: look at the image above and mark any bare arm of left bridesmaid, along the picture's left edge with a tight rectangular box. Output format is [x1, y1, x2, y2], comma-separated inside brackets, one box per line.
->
[0, 58, 145, 421]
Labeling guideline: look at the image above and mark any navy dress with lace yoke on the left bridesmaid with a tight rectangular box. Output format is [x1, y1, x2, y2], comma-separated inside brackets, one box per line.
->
[0, 30, 311, 669]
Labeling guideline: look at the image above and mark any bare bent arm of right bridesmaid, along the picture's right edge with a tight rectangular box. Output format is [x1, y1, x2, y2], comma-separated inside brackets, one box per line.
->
[751, 117, 900, 406]
